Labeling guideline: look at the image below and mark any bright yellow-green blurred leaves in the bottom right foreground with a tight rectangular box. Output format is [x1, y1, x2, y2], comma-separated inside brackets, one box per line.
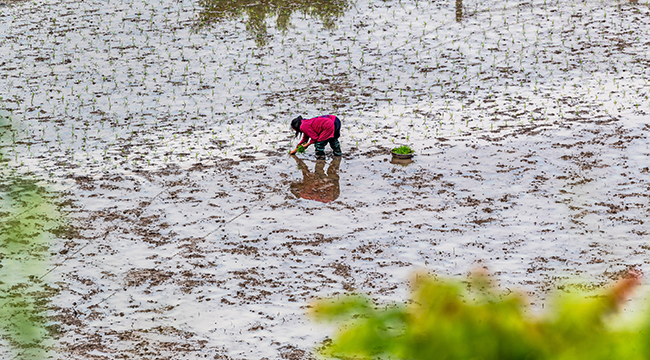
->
[311, 274, 650, 360]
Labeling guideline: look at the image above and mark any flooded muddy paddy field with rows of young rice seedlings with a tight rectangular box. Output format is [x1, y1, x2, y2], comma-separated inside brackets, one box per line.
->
[0, 0, 650, 359]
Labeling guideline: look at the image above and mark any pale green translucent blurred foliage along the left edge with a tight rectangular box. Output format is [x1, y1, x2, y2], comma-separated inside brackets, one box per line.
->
[0, 114, 60, 359]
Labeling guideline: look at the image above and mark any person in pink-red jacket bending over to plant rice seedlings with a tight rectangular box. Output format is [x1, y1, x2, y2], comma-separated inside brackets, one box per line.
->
[290, 115, 342, 156]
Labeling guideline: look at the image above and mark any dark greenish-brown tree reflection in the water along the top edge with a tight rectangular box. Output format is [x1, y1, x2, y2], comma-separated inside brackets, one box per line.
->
[197, 0, 350, 46]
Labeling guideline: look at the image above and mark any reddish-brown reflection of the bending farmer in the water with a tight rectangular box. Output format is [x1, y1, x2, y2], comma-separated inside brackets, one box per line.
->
[290, 155, 341, 203]
